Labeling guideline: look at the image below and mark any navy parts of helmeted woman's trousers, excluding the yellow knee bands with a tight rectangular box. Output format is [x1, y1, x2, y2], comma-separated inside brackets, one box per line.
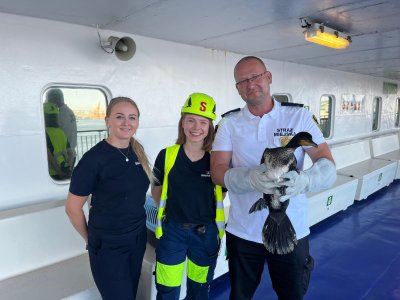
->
[156, 220, 220, 300]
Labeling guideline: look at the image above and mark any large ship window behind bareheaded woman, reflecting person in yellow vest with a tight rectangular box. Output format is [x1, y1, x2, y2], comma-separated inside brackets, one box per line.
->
[43, 85, 108, 180]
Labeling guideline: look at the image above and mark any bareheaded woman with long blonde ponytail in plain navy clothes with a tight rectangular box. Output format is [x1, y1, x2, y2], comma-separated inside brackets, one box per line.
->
[66, 97, 153, 300]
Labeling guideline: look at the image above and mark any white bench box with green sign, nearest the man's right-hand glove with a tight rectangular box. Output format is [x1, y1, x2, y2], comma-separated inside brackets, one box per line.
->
[304, 155, 358, 226]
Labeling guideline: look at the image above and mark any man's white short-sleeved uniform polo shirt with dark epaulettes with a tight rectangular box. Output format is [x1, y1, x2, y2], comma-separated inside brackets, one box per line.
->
[212, 100, 325, 243]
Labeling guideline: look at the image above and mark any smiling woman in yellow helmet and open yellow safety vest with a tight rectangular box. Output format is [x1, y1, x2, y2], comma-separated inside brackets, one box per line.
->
[152, 93, 224, 299]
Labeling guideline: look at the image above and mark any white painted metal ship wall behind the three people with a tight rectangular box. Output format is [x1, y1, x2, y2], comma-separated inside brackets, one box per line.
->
[0, 14, 395, 209]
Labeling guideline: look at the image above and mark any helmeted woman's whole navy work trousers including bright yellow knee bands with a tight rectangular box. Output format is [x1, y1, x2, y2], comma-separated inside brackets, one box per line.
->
[156, 220, 220, 299]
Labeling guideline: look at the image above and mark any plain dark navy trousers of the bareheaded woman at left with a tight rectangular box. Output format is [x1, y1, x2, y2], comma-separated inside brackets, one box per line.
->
[88, 226, 147, 300]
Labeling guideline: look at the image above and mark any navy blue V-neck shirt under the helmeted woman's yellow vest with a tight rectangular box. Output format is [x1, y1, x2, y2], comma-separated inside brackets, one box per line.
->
[154, 146, 215, 224]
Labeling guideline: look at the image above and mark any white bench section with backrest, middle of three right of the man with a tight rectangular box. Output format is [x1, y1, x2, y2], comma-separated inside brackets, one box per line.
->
[331, 140, 397, 200]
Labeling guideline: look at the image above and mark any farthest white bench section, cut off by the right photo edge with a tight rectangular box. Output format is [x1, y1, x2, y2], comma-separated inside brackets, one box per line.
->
[371, 134, 400, 179]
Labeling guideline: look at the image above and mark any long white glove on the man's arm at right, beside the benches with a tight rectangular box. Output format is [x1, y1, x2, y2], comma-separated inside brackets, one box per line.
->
[279, 158, 336, 202]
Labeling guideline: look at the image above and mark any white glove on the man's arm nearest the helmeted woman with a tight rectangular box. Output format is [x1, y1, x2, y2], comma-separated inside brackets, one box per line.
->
[224, 164, 279, 194]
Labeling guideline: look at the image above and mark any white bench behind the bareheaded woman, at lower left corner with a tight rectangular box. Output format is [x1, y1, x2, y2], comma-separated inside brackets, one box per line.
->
[0, 200, 100, 300]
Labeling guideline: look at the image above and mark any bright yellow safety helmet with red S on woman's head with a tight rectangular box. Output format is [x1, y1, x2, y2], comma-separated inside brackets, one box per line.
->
[181, 93, 217, 120]
